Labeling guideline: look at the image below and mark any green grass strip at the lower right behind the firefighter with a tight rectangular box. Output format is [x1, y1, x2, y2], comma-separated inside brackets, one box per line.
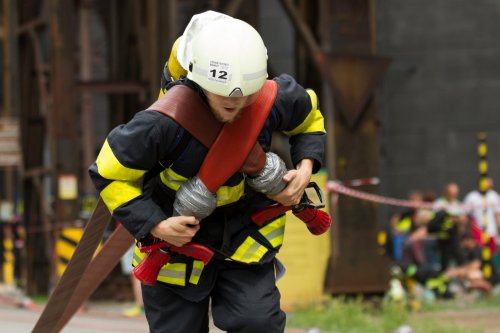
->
[287, 297, 486, 333]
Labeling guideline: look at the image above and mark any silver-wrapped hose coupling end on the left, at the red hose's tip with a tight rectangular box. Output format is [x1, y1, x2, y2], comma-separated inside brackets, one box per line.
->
[174, 176, 217, 219]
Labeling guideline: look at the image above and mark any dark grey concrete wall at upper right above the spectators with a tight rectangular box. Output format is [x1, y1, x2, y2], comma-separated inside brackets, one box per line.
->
[377, 0, 500, 222]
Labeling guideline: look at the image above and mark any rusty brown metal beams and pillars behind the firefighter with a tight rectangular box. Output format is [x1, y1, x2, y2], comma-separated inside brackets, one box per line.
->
[0, 0, 390, 294]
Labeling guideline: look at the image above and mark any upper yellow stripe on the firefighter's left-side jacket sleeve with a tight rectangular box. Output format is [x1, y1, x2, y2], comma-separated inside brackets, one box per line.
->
[96, 140, 146, 181]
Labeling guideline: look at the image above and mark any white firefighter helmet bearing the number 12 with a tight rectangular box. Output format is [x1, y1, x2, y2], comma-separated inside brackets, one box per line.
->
[178, 12, 267, 97]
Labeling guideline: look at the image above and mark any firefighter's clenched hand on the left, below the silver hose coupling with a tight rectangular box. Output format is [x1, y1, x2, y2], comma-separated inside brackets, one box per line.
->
[151, 216, 200, 247]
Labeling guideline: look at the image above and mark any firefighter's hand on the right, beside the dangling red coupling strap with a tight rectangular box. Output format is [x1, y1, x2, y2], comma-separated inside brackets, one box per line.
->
[269, 159, 314, 206]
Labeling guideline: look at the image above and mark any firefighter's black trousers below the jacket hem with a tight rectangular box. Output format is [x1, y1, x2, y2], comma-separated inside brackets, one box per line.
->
[142, 263, 286, 333]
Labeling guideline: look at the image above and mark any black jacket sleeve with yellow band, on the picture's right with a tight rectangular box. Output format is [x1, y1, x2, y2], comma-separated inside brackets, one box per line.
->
[270, 74, 326, 172]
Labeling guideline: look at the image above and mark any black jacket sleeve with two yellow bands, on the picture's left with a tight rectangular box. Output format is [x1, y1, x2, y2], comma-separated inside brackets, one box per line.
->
[89, 111, 179, 239]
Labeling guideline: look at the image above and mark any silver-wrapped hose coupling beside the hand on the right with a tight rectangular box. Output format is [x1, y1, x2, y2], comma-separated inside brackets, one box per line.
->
[247, 152, 287, 195]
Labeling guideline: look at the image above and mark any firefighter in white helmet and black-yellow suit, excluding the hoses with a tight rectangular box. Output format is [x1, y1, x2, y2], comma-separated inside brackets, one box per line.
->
[89, 11, 326, 333]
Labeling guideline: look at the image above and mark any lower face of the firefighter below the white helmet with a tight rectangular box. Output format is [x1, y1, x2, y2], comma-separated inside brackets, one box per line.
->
[205, 91, 256, 123]
